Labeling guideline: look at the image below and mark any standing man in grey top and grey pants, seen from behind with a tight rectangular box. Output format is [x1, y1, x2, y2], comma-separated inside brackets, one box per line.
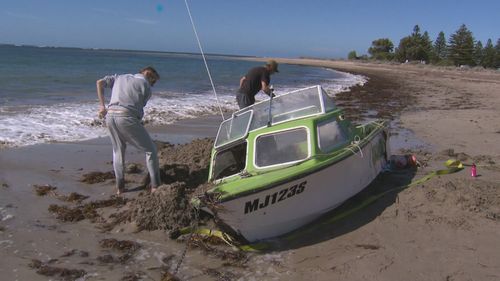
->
[96, 66, 160, 195]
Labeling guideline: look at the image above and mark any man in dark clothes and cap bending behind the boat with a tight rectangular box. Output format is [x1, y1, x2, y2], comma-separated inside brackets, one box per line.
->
[236, 60, 279, 109]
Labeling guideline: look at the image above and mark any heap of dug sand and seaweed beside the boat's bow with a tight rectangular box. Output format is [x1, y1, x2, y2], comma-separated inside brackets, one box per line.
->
[124, 138, 213, 230]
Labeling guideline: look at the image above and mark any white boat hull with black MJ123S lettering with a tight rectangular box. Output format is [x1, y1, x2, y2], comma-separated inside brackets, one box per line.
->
[218, 130, 388, 242]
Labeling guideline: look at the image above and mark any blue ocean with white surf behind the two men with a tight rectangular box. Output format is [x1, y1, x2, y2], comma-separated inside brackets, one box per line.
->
[0, 45, 366, 147]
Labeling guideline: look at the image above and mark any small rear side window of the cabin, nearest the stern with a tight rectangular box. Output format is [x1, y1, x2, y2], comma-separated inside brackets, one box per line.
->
[318, 119, 348, 152]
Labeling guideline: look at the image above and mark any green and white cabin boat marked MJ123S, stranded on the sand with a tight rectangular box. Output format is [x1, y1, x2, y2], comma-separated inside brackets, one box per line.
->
[201, 86, 388, 242]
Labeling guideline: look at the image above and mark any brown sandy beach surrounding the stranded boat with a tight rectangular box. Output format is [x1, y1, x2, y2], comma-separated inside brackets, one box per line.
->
[0, 58, 500, 281]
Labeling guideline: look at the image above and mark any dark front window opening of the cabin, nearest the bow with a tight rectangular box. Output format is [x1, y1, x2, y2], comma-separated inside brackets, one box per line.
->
[213, 142, 247, 179]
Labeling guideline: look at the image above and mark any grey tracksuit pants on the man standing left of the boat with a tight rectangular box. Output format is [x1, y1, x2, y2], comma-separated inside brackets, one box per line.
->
[106, 113, 161, 189]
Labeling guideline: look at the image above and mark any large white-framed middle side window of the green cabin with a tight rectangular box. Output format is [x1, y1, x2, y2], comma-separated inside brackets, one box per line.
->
[255, 128, 309, 167]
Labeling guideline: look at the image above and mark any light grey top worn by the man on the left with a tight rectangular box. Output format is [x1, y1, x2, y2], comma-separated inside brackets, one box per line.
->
[102, 73, 151, 119]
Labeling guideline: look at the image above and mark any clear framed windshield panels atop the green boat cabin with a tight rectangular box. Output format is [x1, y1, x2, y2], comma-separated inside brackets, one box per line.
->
[215, 86, 336, 148]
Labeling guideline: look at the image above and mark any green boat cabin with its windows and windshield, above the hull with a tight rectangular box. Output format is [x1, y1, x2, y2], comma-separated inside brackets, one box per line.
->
[209, 86, 352, 182]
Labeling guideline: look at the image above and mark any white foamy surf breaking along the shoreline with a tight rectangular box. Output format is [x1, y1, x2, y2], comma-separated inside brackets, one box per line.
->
[0, 69, 367, 146]
